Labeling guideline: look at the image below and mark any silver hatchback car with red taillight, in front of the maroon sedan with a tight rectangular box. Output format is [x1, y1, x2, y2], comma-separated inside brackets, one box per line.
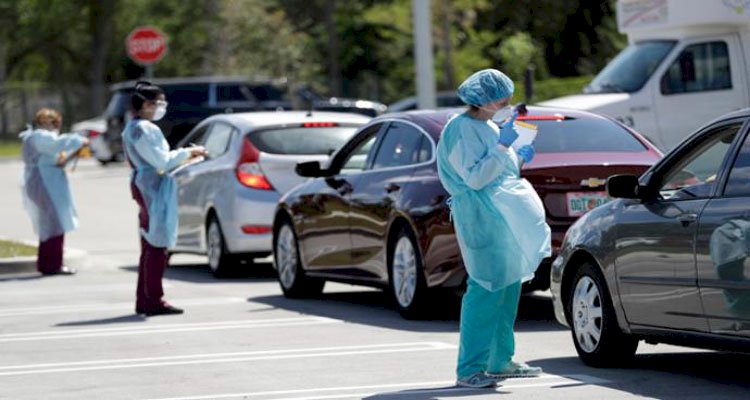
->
[170, 111, 370, 276]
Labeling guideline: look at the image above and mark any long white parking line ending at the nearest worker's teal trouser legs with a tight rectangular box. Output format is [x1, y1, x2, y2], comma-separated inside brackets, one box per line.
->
[0, 342, 455, 376]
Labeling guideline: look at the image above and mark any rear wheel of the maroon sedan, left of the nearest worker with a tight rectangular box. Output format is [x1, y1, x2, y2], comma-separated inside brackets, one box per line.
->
[388, 226, 429, 319]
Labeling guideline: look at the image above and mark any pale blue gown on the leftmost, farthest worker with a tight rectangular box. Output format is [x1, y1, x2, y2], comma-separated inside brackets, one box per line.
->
[19, 129, 85, 242]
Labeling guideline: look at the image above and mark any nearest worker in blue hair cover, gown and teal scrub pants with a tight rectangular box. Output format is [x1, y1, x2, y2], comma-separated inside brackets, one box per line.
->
[438, 69, 551, 387]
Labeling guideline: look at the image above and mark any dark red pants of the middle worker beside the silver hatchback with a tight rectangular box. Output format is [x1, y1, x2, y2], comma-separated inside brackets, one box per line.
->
[130, 182, 169, 312]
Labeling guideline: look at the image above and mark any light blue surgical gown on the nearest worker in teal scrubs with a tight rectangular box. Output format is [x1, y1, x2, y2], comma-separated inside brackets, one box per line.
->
[438, 114, 551, 291]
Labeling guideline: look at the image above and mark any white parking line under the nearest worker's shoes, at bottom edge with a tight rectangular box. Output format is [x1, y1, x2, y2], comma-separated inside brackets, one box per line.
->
[145, 375, 609, 400]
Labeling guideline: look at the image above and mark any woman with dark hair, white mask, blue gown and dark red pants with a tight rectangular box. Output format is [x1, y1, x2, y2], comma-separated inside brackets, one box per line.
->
[122, 82, 206, 316]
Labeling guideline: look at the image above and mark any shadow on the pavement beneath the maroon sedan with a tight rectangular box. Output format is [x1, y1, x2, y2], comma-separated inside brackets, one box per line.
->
[248, 289, 566, 332]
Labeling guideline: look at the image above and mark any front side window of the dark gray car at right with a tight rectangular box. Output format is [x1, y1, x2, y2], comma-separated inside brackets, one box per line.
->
[659, 124, 742, 200]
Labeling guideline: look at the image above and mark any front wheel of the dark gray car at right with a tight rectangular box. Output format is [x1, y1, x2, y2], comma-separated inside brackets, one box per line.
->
[568, 263, 638, 367]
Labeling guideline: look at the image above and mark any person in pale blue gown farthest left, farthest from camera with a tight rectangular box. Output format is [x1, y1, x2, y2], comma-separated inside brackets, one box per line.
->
[19, 108, 89, 275]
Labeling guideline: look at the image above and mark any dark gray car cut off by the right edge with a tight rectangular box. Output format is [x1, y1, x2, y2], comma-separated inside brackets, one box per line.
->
[550, 109, 750, 366]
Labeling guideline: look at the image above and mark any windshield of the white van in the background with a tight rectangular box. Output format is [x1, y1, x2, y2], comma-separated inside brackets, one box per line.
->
[583, 40, 676, 93]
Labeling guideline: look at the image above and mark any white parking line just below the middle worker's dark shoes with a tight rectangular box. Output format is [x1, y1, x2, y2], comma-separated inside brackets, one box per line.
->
[0, 317, 342, 342]
